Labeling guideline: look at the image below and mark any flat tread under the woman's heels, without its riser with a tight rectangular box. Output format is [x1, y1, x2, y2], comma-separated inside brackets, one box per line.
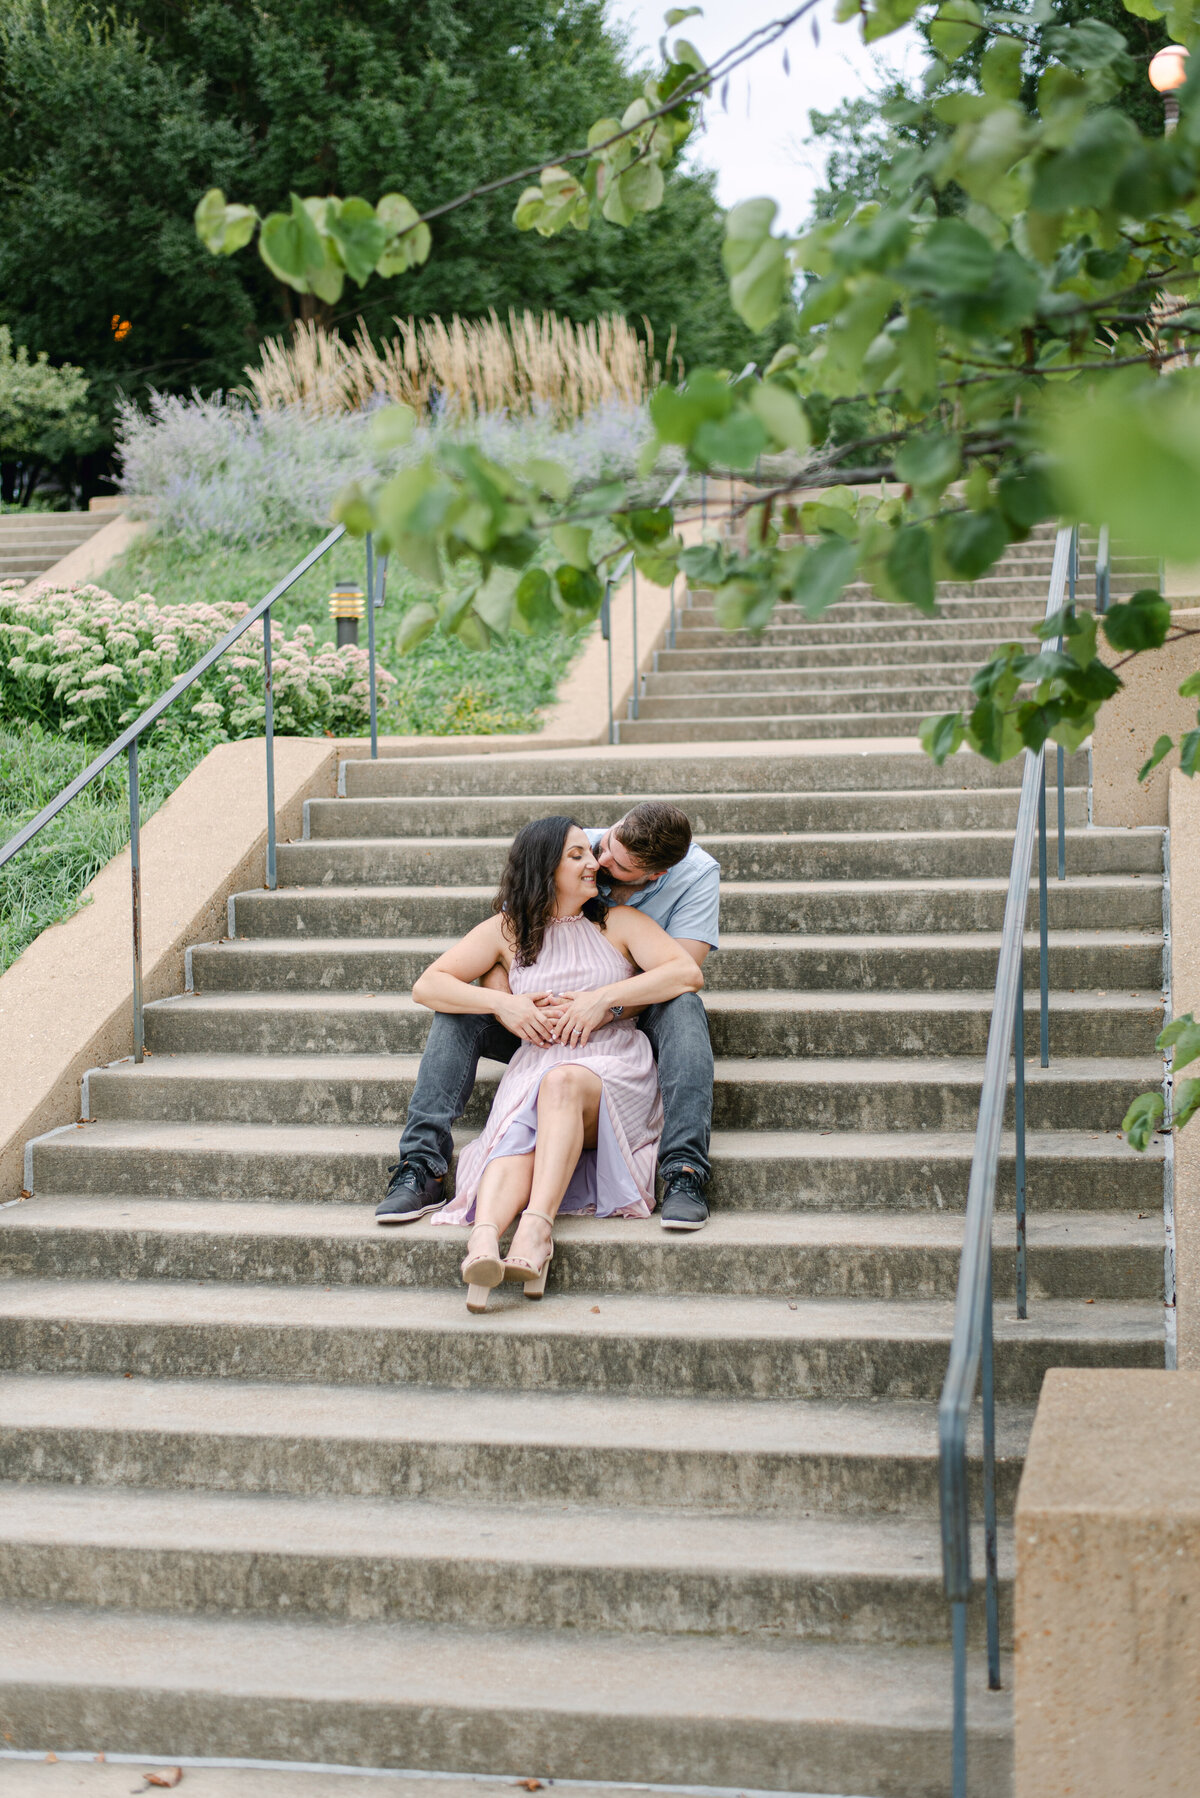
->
[0, 1278, 1162, 1345]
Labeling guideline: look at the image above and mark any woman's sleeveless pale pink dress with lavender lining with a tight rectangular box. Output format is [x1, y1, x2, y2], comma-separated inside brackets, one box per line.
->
[430, 917, 662, 1224]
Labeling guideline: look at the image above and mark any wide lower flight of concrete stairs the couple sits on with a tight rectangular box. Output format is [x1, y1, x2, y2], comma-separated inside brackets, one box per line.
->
[0, 553, 1162, 1798]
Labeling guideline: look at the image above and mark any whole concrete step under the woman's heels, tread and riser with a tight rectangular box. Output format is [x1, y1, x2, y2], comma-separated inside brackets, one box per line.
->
[0, 1280, 1164, 1402]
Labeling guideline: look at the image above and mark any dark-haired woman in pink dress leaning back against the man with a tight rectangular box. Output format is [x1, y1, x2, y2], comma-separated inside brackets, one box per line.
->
[412, 816, 703, 1311]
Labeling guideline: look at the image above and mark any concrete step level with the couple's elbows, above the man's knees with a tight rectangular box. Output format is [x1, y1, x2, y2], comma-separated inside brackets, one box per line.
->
[189, 930, 1162, 994]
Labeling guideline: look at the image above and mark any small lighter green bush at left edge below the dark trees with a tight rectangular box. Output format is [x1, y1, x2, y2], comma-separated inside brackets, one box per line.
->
[0, 325, 99, 505]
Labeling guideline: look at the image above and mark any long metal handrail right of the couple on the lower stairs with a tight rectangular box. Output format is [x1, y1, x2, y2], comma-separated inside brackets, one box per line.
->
[937, 527, 1078, 1798]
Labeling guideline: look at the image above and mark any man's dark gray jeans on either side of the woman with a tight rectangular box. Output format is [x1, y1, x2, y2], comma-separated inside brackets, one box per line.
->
[399, 992, 712, 1183]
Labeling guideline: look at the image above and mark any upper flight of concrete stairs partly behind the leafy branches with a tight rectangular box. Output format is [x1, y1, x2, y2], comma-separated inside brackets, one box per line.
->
[619, 525, 1159, 743]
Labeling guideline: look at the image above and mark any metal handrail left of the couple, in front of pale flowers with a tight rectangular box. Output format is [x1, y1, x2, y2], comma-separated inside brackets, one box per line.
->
[0, 525, 376, 1061]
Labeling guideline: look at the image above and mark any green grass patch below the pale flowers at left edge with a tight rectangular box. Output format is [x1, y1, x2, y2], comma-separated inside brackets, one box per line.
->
[0, 725, 210, 975]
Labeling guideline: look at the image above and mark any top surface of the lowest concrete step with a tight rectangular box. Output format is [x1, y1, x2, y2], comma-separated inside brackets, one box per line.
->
[0, 1607, 1011, 1753]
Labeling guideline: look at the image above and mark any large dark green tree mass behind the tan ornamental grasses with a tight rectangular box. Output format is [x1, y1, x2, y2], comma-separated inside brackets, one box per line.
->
[0, 0, 770, 481]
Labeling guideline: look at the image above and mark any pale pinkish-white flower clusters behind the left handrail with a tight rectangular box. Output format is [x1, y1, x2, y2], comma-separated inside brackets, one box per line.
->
[0, 581, 394, 743]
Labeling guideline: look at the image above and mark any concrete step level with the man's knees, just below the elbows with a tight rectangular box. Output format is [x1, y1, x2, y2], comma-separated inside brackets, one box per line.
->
[146, 991, 1162, 1059]
